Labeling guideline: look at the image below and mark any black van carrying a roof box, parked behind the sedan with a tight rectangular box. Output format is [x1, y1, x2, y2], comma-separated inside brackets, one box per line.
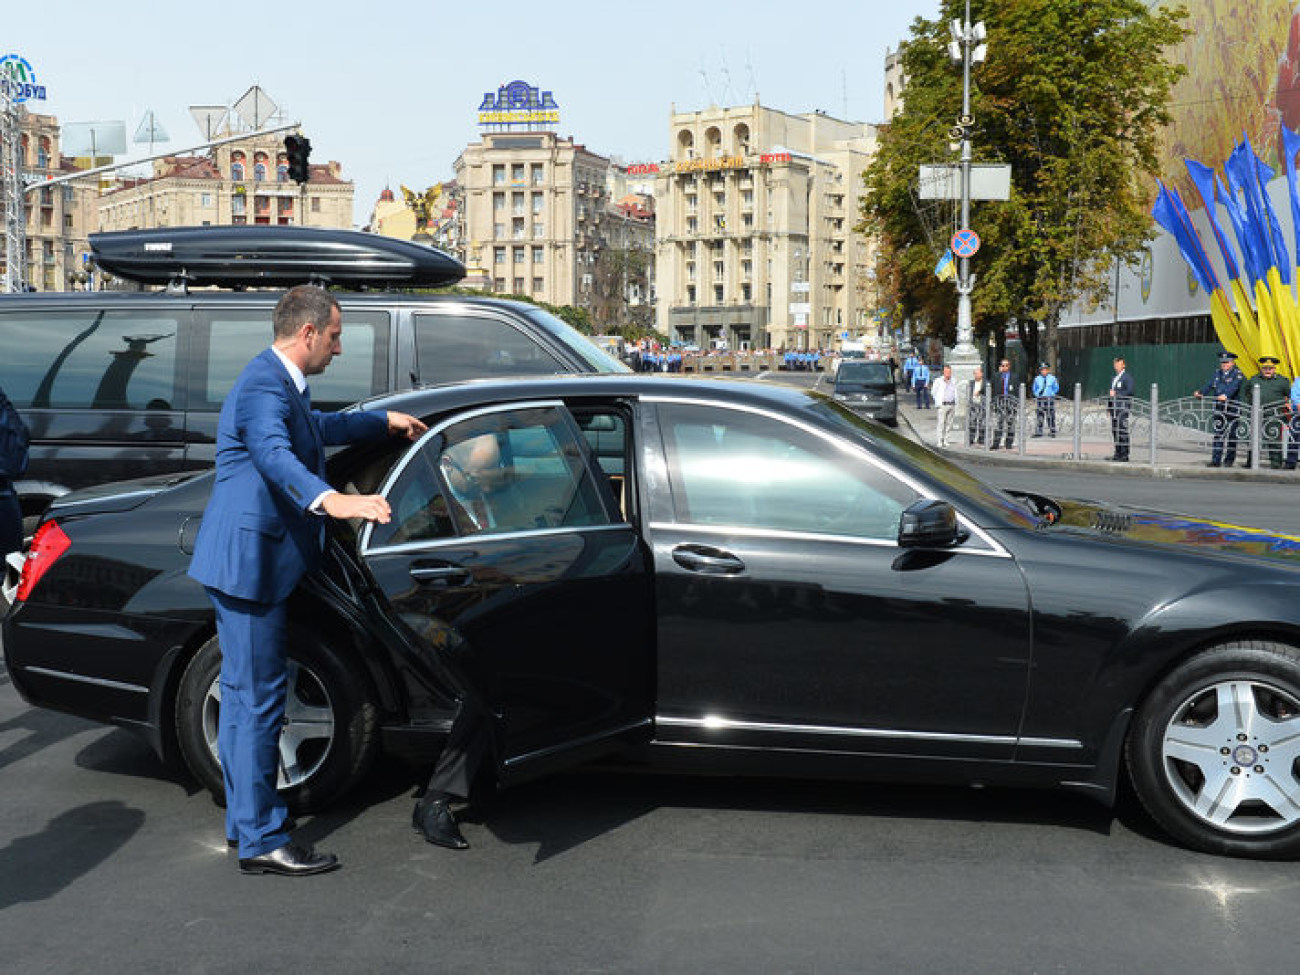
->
[0, 226, 627, 524]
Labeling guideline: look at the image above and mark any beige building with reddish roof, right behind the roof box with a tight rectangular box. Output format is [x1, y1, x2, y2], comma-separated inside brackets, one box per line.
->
[99, 135, 354, 230]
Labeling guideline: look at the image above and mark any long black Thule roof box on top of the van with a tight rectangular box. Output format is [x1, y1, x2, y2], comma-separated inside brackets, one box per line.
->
[90, 225, 465, 289]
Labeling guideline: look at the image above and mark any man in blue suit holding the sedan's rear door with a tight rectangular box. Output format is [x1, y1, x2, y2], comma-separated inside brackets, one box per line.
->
[190, 285, 425, 876]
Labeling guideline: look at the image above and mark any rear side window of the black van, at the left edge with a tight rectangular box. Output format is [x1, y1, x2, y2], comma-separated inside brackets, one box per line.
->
[0, 308, 181, 410]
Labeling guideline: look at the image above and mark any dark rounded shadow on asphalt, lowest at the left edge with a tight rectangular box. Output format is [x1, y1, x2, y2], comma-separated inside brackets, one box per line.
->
[0, 801, 144, 911]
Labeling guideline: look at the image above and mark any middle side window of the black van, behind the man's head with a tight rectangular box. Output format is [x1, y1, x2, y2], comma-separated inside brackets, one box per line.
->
[191, 308, 390, 410]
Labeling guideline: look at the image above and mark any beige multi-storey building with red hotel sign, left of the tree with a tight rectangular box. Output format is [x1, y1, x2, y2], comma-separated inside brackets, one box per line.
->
[655, 103, 875, 350]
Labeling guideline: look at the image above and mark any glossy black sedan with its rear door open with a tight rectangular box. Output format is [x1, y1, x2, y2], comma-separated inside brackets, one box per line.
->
[4, 376, 1300, 857]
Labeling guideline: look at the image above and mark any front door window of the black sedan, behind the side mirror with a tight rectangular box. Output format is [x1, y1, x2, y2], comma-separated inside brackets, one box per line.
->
[659, 404, 920, 541]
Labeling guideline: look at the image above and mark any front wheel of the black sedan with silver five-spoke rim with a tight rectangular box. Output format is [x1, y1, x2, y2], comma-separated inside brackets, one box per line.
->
[1126, 641, 1300, 859]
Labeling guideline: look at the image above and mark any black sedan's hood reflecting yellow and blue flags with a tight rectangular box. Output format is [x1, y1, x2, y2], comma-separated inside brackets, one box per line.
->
[1053, 499, 1300, 568]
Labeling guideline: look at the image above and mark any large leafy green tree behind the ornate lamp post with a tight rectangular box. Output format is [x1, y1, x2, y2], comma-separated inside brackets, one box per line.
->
[859, 0, 1187, 363]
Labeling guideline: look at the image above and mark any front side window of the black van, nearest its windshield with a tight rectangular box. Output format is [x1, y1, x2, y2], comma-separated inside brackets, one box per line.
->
[415, 313, 569, 384]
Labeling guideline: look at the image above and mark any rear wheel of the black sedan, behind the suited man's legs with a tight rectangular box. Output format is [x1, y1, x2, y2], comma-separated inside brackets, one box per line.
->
[176, 628, 378, 813]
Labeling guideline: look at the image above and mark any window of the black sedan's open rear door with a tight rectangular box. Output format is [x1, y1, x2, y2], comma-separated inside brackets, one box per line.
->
[368, 407, 612, 549]
